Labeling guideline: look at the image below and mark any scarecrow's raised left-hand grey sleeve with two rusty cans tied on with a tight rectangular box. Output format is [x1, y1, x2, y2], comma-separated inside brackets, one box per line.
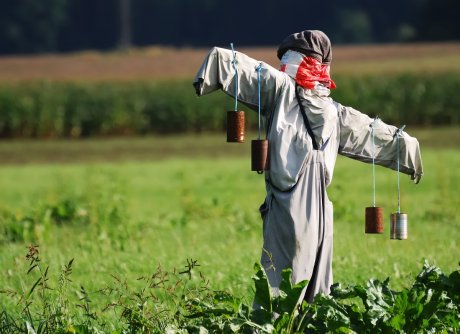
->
[193, 47, 286, 113]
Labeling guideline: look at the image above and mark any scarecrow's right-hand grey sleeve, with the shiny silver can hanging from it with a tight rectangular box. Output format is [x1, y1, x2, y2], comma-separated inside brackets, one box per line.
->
[339, 105, 423, 183]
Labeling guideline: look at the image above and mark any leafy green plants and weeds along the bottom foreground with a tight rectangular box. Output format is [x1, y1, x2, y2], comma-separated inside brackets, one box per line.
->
[0, 246, 460, 334]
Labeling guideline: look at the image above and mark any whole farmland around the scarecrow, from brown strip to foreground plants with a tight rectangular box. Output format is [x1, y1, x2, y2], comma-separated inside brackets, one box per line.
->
[0, 43, 460, 334]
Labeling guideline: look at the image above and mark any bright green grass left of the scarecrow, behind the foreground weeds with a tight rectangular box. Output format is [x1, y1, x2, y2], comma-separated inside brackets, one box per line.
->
[0, 158, 262, 320]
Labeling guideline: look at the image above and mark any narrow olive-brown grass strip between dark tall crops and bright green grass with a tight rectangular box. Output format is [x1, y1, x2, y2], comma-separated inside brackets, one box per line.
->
[0, 126, 460, 165]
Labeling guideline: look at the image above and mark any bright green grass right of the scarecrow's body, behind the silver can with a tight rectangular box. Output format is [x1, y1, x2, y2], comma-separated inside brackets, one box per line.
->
[330, 149, 460, 286]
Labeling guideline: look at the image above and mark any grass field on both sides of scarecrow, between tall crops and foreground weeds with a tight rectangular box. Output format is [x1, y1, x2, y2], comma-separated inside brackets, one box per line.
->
[0, 128, 460, 328]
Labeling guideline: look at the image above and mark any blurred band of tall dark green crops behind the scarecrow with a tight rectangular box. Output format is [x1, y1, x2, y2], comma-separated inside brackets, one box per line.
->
[0, 74, 460, 138]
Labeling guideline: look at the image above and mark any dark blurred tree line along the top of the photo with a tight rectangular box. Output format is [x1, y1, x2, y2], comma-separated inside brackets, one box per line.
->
[0, 0, 460, 54]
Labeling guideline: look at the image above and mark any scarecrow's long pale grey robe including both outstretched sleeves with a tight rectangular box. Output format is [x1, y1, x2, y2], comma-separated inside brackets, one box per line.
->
[194, 47, 423, 302]
